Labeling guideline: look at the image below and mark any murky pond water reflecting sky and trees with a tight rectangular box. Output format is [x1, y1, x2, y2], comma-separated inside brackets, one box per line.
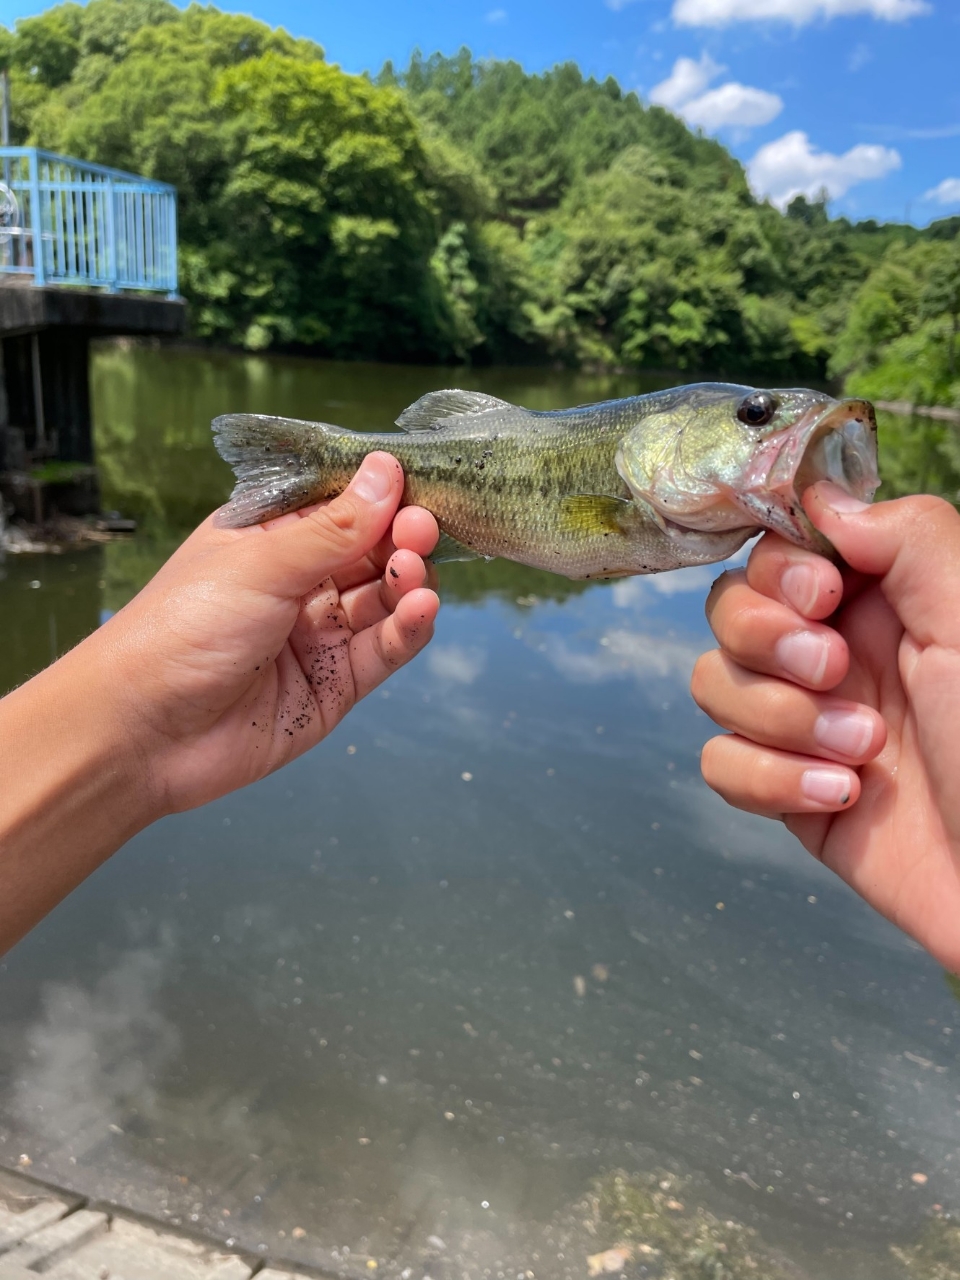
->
[0, 346, 960, 1280]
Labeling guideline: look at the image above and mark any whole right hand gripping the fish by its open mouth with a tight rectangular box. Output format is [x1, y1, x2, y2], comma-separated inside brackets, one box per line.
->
[691, 483, 960, 972]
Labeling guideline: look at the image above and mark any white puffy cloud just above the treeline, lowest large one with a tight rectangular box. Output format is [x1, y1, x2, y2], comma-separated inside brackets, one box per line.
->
[748, 129, 901, 209]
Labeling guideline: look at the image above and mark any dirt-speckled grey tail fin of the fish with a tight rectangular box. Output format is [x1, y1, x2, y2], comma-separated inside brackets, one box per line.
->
[212, 413, 342, 529]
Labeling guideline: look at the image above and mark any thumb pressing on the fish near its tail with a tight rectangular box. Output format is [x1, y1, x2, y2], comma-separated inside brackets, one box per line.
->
[244, 452, 403, 596]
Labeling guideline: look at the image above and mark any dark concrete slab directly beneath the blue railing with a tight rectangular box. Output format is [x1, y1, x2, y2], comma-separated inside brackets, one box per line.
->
[0, 279, 187, 338]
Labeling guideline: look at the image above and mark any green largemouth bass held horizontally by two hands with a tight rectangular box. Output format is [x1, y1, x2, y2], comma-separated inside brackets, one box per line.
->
[212, 383, 879, 579]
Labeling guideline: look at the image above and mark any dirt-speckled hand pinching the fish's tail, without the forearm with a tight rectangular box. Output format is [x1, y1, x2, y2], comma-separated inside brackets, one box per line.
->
[94, 453, 439, 815]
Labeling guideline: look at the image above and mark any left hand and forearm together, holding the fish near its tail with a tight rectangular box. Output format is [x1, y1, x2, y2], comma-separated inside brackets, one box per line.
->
[0, 453, 438, 952]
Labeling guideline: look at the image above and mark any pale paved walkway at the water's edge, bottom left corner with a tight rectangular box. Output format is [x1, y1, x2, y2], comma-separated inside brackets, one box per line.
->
[0, 1170, 316, 1280]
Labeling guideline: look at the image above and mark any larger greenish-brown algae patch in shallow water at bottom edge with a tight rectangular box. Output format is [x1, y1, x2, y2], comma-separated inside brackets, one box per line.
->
[585, 1170, 798, 1280]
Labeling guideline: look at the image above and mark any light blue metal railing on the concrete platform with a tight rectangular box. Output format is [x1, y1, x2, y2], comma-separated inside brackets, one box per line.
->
[0, 147, 177, 297]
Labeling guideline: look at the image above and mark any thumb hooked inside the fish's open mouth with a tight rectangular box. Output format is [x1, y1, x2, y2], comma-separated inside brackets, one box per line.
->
[803, 481, 960, 645]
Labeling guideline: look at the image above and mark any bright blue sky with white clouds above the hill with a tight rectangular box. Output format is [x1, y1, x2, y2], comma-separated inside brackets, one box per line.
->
[0, 0, 960, 224]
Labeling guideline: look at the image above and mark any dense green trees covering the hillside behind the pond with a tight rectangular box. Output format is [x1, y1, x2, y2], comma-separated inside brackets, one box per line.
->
[0, 0, 960, 402]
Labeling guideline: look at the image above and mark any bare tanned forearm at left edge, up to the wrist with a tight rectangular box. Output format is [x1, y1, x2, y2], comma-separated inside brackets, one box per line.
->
[0, 636, 159, 954]
